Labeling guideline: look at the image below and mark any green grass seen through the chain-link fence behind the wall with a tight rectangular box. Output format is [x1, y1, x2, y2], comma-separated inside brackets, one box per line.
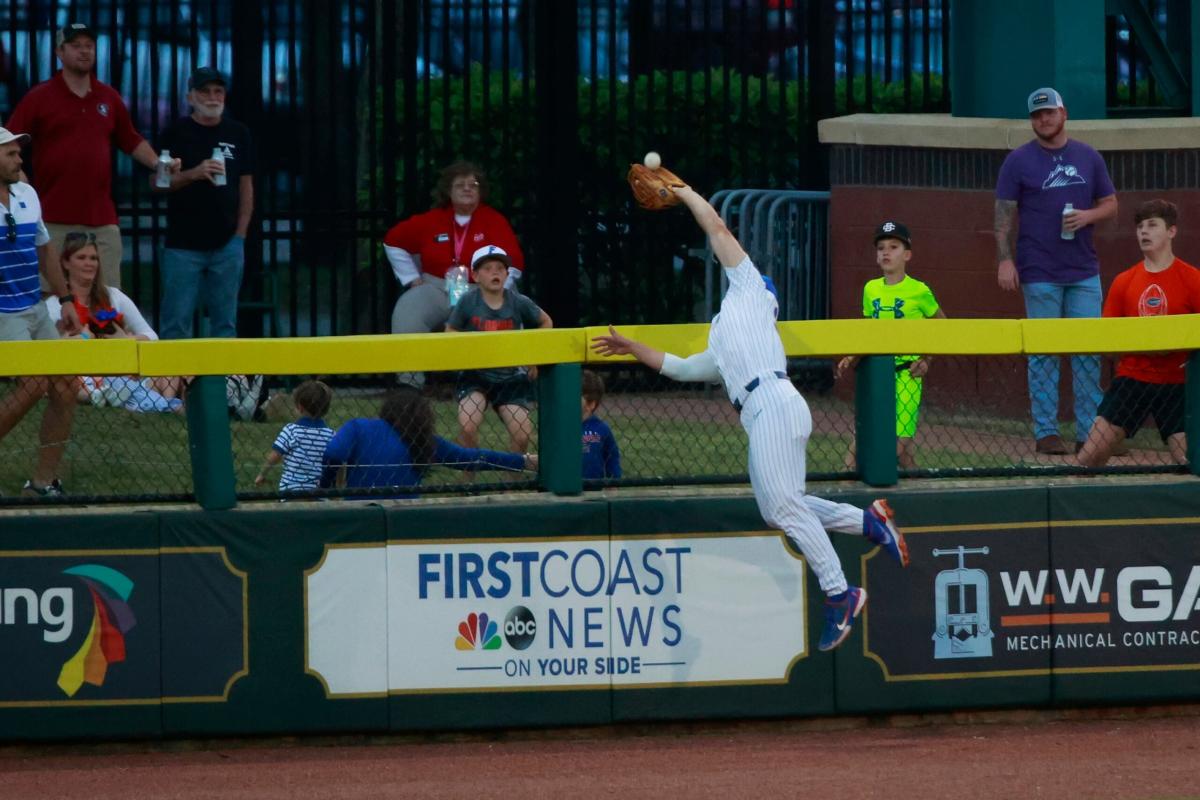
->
[0, 383, 1180, 497]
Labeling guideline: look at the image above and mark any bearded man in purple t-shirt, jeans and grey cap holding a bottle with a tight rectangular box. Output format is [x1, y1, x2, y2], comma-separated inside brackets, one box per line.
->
[996, 89, 1117, 456]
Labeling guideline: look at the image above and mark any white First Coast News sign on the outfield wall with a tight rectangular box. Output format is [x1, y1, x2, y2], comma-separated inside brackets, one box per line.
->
[305, 533, 806, 697]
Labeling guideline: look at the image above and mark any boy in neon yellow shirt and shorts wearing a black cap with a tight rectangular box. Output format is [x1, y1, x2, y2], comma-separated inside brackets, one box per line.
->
[838, 222, 946, 469]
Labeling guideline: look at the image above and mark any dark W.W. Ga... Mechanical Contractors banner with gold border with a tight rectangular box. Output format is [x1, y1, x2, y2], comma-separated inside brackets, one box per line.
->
[864, 519, 1200, 681]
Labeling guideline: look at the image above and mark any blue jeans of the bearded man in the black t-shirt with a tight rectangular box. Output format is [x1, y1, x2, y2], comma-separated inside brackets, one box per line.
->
[158, 236, 246, 339]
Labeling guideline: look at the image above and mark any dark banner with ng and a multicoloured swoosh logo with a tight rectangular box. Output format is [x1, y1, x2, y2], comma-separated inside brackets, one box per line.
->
[0, 548, 246, 708]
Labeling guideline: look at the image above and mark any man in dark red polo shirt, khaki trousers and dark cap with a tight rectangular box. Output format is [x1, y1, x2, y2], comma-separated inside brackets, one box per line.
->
[7, 23, 179, 291]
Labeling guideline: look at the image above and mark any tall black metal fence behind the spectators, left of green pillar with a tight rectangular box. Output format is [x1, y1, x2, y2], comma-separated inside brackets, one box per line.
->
[0, 0, 949, 336]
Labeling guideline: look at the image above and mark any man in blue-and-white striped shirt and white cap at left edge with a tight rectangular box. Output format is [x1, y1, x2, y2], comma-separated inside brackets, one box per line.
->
[0, 128, 79, 497]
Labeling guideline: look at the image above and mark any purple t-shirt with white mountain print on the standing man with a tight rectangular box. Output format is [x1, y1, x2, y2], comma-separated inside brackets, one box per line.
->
[996, 139, 1116, 283]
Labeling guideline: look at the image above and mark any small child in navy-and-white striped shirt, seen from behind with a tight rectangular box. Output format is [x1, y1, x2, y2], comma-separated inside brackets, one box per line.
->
[254, 380, 334, 492]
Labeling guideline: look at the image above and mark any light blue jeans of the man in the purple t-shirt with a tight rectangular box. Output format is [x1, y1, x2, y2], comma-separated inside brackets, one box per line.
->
[1021, 275, 1104, 441]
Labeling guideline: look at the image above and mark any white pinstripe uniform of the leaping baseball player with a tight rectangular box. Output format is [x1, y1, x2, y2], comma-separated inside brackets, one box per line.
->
[662, 257, 863, 594]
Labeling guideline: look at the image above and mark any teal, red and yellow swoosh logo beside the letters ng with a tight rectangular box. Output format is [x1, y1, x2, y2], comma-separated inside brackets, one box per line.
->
[59, 564, 138, 697]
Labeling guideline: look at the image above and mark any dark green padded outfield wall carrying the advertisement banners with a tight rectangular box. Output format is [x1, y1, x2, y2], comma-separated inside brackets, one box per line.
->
[0, 480, 1200, 740]
